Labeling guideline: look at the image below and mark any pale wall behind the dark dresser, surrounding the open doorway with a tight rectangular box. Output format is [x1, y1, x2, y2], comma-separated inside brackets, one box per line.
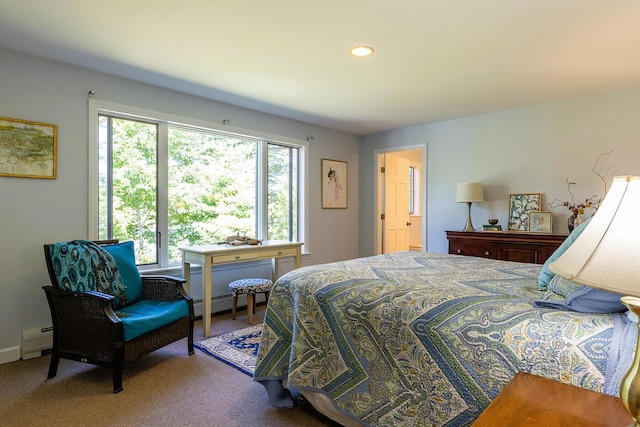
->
[360, 88, 640, 256]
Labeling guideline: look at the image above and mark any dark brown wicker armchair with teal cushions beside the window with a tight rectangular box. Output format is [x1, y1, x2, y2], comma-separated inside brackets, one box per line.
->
[43, 240, 194, 393]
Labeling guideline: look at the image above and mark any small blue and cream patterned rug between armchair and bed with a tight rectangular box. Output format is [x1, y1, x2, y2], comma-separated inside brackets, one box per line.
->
[194, 323, 262, 376]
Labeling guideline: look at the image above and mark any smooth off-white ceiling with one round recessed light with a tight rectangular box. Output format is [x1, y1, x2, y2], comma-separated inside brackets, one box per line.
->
[0, 0, 640, 135]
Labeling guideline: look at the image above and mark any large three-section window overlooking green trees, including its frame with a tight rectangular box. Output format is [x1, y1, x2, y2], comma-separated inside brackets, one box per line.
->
[90, 101, 305, 267]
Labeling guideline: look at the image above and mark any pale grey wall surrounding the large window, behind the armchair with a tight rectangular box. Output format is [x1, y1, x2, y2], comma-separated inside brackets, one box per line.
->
[0, 49, 359, 363]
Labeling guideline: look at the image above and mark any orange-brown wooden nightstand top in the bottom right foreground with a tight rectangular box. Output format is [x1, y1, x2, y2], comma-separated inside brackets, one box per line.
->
[472, 372, 634, 427]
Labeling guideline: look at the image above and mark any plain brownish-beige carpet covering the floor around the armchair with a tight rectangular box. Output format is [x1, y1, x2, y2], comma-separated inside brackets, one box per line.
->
[0, 306, 336, 427]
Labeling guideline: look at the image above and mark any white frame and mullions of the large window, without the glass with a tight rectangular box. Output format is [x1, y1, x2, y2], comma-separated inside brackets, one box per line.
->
[87, 98, 309, 269]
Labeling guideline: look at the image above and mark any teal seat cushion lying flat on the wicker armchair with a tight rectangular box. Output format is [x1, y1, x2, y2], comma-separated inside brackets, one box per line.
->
[116, 300, 189, 341]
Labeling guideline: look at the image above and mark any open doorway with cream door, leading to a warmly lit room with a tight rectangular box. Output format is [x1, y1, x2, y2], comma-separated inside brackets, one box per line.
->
[375, 144, 427, 254]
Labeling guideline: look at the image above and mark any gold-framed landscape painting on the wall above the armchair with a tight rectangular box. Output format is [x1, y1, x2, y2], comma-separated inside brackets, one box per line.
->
[0, 117, 58, 179]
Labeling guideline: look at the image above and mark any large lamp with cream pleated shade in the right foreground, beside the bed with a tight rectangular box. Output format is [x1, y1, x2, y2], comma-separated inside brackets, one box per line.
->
[549, 176, 640, 427]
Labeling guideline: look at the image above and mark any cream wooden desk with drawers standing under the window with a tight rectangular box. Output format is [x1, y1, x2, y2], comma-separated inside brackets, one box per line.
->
[180, 240, 303, 337]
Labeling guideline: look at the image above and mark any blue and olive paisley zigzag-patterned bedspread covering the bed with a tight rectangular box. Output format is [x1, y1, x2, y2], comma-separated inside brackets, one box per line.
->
[254, 252, 637, 426]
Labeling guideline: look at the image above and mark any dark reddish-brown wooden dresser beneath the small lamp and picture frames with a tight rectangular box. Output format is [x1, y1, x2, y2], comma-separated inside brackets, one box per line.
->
[446, 231, 567, 264]
